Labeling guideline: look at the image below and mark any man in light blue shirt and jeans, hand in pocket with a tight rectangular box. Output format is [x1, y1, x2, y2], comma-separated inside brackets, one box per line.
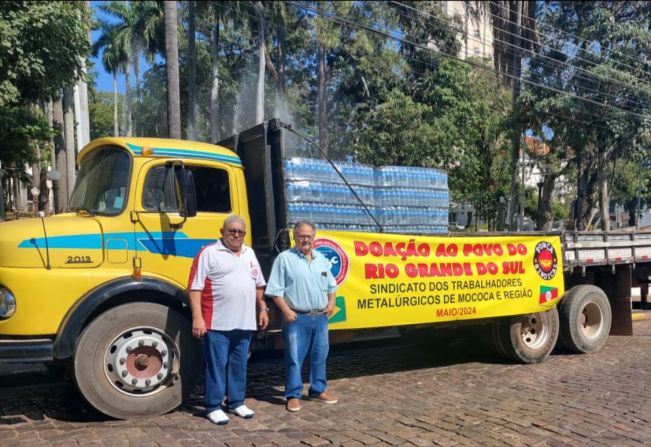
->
[265, 220, 337, 411]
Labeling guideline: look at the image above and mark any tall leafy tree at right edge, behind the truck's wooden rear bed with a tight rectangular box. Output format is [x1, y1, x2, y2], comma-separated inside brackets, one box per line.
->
[521, 2, 651, 229]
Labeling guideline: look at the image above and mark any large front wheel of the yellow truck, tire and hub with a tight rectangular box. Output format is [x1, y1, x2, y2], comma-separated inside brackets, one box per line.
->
[73, 303, 200, 419]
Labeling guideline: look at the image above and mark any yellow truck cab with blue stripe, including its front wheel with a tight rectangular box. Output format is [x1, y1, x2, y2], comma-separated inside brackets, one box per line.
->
[0, 138, 251, 417]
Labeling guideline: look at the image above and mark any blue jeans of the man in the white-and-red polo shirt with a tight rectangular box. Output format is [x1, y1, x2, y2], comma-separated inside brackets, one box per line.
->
[204, 329, 251, 413]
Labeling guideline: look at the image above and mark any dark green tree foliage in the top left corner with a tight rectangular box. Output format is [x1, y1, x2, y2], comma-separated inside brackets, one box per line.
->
[0, 1, 90, 184]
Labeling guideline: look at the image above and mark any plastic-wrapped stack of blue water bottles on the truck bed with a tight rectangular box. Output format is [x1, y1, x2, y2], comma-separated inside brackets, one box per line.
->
[284, 158, 449, 233]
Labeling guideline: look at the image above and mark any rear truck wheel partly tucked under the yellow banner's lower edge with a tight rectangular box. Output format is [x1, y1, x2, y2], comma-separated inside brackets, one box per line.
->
[492, 308, 559, 363]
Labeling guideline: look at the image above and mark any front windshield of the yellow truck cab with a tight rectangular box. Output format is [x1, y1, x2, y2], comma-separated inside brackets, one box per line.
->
[70, 147, 131, 216]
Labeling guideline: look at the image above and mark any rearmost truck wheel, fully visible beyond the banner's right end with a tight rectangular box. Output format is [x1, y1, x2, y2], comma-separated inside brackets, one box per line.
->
[558, 284, 612, 354]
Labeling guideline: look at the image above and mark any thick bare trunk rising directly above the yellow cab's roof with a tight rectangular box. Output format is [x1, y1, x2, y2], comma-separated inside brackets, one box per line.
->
[163, 1, 181, 138]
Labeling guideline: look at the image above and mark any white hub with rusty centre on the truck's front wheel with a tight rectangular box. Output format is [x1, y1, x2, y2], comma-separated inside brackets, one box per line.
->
[105, 329, 173, 394]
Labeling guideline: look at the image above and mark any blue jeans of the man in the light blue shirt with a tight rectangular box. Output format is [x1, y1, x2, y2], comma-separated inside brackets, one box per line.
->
[283, 314, 329, 399]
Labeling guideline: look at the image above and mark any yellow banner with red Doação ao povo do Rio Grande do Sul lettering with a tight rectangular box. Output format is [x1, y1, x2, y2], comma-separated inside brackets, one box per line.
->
[314, 231, 564, 329]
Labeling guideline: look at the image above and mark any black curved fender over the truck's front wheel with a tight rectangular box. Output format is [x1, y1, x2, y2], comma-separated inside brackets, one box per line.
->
[54, 276, 188, 360]
